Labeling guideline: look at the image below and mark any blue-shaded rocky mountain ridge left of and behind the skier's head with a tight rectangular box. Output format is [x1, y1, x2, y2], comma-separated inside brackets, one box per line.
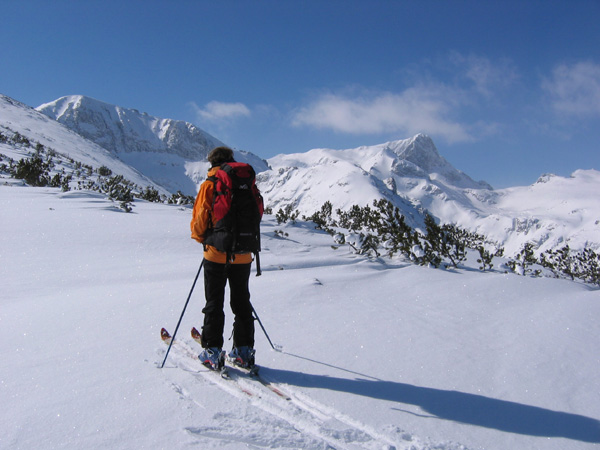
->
[36, 95, 267, 196]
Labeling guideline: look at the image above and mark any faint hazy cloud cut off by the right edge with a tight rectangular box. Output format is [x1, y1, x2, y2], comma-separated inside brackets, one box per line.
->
[542, 62, 600, 117]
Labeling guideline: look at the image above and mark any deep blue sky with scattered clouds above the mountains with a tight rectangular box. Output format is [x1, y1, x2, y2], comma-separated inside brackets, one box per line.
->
[0, 0, 600, 187]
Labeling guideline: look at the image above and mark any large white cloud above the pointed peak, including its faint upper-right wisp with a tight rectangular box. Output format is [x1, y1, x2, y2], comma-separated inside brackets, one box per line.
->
[292, 52, 519, 143]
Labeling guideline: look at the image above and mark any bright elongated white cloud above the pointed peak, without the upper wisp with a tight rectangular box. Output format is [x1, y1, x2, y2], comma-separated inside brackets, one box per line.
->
[292, 85, 473, 142]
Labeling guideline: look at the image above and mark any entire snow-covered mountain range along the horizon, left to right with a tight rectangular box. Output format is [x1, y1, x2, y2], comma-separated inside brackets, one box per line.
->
[5, 92, 600, 256]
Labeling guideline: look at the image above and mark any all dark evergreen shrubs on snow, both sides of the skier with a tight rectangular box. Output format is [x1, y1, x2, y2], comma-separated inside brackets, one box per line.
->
[0, 125, 600, 287]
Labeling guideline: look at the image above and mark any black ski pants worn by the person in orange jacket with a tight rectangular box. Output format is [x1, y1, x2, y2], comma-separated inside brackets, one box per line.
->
[202, 260, 254, 348]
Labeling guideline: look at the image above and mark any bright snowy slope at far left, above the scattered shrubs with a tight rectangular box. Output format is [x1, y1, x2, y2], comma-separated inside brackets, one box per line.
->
[0, 94, 167, 194]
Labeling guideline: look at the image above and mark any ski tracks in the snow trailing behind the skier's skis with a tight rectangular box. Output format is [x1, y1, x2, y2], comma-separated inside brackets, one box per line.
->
[161, 340, 454, 450]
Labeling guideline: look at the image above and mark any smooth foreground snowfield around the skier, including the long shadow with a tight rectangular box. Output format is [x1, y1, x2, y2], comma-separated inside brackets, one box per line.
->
[0, 184, 600, 450]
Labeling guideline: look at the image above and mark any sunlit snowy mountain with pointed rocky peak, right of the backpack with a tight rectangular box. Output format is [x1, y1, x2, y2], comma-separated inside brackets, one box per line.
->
[259, 134, 491, 224]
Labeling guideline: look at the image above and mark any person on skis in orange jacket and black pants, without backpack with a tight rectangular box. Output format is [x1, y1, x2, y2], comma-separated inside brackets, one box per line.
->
[190, 147, 262, 370]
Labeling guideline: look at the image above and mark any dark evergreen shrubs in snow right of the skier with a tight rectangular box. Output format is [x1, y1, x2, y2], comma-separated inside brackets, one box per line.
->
[296, 199, 600, 287]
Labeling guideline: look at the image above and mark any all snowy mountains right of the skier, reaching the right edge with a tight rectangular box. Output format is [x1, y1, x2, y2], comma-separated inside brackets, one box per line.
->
[259, 134, 600, 255]
